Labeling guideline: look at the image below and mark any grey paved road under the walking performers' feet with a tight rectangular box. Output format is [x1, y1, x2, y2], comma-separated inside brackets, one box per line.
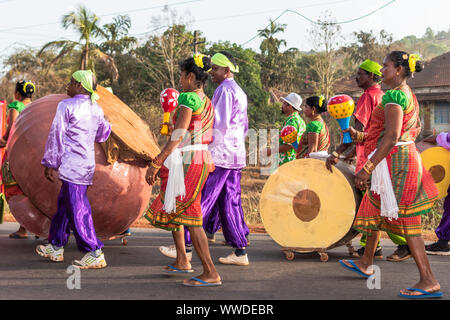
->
[0, 223, 450, 300]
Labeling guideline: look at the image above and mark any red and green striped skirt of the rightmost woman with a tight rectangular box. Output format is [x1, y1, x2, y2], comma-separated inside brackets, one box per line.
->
[353, 144, 438, 237]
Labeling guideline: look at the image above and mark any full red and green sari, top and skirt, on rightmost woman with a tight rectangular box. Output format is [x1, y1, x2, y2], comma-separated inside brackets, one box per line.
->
[353, 87, 438, 237]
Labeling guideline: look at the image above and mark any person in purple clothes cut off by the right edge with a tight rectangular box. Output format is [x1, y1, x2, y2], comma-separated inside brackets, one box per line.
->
[424, 132, 450, 256]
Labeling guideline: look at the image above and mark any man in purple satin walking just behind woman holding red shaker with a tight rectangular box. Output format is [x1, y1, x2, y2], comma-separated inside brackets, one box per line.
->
[160, 51, 249, 266]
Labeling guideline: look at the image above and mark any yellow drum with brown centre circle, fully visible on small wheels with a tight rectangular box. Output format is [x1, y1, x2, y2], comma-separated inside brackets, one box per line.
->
[260, 159, 362, 261]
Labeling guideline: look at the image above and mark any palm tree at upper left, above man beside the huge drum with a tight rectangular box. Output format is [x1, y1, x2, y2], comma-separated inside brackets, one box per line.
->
[39, 6, 118, 81]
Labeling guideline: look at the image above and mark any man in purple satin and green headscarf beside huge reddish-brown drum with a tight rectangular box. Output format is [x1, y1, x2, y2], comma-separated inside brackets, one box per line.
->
[36, 70, 111, 269]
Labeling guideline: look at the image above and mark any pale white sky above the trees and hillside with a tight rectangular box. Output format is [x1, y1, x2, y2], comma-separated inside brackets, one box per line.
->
[0, 0, 450, 62]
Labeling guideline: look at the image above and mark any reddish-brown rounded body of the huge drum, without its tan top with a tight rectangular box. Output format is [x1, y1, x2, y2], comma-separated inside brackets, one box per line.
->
[7, 94, 155, 239]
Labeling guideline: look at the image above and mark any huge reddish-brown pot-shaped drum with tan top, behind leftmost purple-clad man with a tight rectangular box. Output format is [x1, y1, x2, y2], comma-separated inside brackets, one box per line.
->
[7, 87, 159, 239]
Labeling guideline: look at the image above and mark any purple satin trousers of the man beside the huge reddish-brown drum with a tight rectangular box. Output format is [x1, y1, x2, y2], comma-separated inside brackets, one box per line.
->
[48, 180, 103, 252]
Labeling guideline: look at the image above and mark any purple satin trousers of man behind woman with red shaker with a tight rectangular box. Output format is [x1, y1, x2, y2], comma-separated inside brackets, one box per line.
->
[184, 167, 250, 248]
